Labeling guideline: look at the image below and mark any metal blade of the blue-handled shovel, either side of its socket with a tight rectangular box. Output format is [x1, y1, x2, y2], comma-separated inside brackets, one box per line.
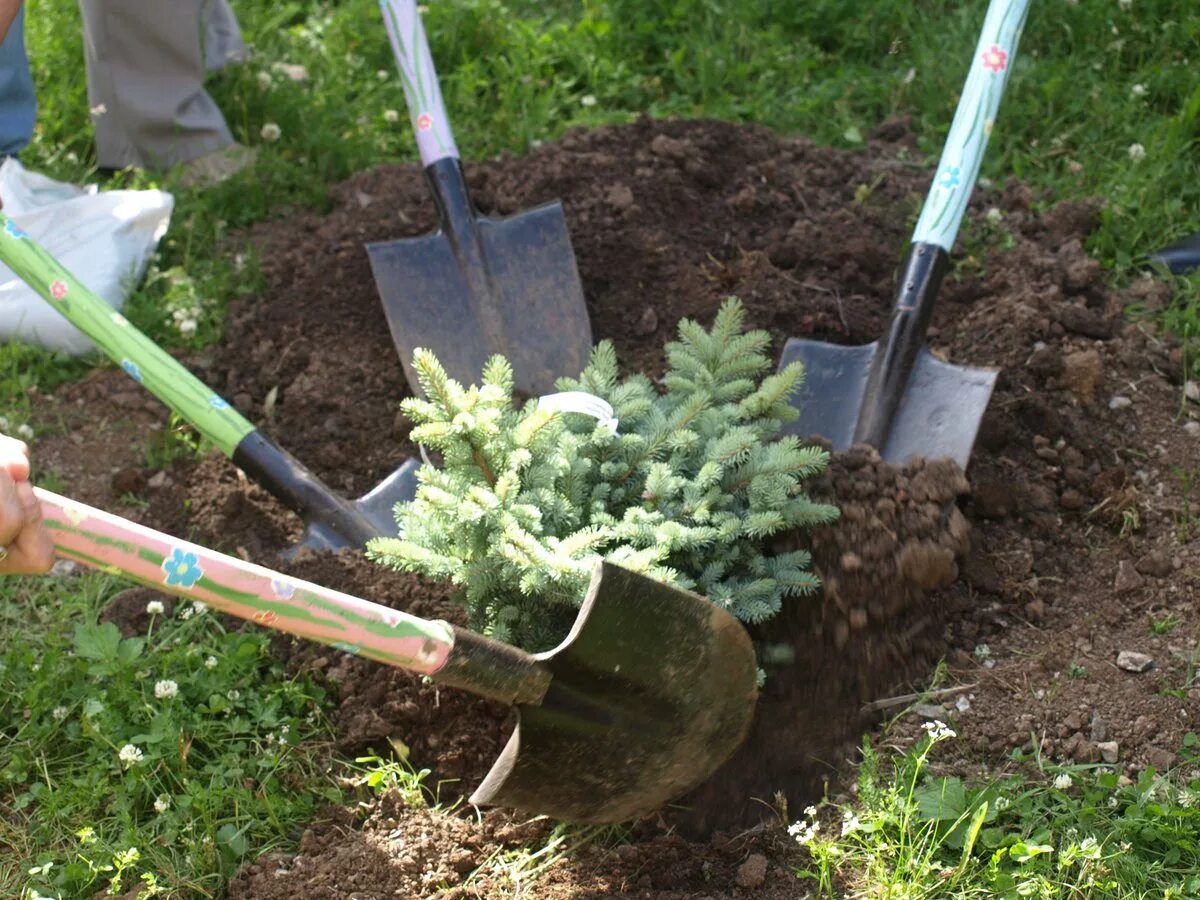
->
[780, 337, 996, 468]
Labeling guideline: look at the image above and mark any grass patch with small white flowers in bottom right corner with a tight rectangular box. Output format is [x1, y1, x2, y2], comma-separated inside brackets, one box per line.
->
[788, 722, 1200, 900]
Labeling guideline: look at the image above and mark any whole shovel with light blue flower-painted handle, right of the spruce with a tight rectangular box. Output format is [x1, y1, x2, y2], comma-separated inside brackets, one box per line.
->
[780, 0, 1028, 468]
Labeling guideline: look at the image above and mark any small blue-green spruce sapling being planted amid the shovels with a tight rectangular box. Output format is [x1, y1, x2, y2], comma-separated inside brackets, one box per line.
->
[367, 298, 838, 649]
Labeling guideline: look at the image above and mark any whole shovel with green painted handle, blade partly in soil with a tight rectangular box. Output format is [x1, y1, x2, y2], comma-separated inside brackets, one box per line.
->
[0, 218, 420, 550]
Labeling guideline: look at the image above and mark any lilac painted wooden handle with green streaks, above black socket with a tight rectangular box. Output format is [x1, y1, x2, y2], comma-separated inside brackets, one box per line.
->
[379, 0, 458, 167]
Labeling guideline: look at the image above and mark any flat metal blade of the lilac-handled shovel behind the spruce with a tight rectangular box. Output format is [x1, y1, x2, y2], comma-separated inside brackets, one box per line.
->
[367, 202, 592, 396]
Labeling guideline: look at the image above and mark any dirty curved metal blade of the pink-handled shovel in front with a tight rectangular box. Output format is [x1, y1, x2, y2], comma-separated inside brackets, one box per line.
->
[470, 563, 757, 823]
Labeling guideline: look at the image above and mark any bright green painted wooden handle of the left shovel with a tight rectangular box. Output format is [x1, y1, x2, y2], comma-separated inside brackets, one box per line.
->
[0, 212, 254, 456]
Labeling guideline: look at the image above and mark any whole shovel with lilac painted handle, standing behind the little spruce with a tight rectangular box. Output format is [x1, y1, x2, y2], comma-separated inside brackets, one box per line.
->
[367, 0, 592, 396]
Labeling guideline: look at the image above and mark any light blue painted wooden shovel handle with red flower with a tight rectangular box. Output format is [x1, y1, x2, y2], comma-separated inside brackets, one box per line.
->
[912, 0, 1028, 253]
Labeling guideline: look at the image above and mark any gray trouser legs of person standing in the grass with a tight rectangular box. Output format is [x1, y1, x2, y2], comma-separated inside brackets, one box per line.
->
[79, 0, 245, 168]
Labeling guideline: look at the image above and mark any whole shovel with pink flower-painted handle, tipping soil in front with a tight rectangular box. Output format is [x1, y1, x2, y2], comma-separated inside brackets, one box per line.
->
[35, 488, 757, 823]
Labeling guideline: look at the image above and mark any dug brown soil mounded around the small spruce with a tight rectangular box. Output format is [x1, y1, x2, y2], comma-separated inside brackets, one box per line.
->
[35, 121, 1200, 900]
